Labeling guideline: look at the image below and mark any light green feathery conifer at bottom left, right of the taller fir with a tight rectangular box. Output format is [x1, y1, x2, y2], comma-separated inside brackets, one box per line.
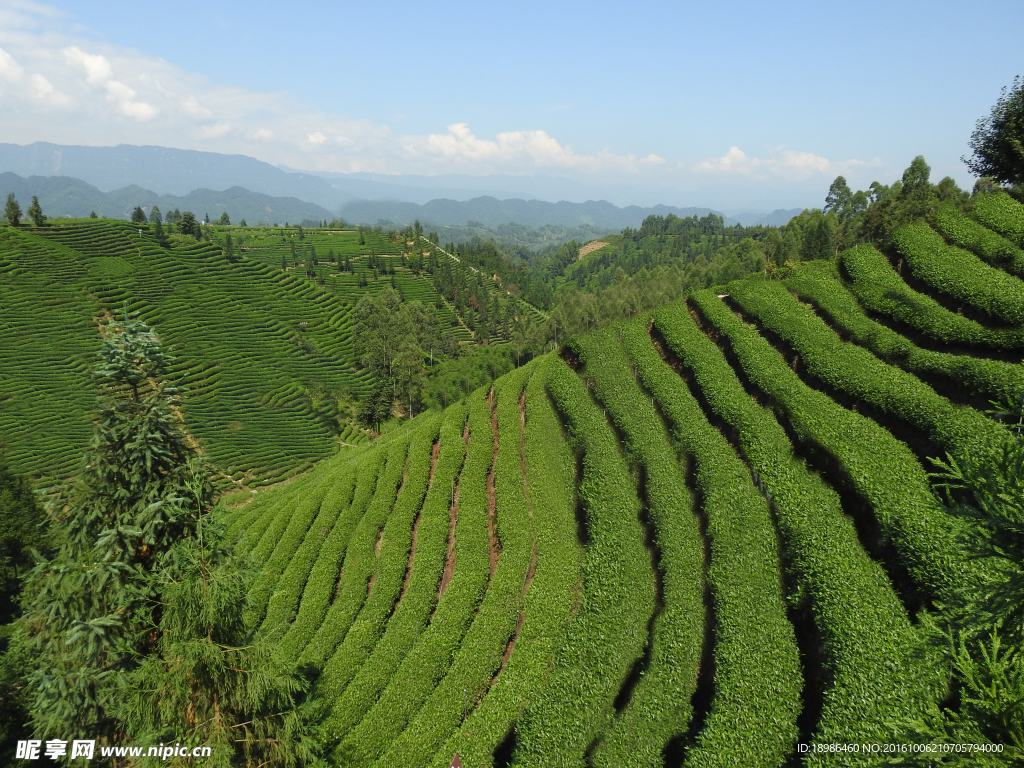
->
[117, 505, 324, 768]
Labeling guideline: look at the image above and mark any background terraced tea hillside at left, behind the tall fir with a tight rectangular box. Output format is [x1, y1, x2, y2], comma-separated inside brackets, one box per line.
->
[0, 220, 385, 483]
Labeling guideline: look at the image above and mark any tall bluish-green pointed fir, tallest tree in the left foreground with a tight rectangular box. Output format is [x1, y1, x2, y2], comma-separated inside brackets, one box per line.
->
[26, 309, 196, 743]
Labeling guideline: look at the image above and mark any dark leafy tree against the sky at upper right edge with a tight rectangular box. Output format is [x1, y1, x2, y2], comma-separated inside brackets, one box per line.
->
[961, 76, 1024, 193]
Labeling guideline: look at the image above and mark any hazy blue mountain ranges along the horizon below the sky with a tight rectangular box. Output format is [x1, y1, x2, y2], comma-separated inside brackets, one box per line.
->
[0, 141, 800, 229]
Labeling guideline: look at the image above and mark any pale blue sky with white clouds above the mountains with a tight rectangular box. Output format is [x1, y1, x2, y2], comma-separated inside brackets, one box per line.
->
[0, 0, 1024, 208]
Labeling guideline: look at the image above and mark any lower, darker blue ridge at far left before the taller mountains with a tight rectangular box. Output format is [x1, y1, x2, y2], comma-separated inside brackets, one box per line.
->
[0, 173, 337, 226]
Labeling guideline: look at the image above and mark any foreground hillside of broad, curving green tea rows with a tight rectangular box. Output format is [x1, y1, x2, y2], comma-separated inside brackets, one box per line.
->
[230, 188, 1024, 768]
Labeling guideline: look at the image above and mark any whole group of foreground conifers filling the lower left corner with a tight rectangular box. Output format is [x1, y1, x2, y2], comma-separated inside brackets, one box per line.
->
[0, 313, 323, 767]
